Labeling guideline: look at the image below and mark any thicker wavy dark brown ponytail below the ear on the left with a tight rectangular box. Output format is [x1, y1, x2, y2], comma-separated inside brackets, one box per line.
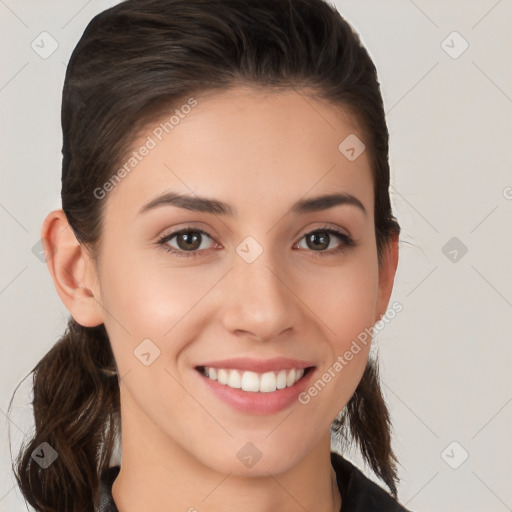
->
[11, 317, 120, 512]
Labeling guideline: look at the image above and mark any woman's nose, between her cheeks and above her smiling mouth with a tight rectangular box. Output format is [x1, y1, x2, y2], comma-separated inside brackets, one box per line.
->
[216, 246, 301, 341]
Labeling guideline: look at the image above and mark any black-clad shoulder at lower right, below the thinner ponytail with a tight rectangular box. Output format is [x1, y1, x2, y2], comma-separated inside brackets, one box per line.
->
[331, 452, 411, 512]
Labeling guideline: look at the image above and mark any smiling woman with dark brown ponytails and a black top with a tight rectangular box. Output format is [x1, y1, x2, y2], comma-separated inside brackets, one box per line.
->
[11, 0, 412, 512]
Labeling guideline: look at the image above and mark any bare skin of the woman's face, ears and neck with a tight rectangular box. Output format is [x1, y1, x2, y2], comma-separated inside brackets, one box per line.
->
[42, 87, 398, 512]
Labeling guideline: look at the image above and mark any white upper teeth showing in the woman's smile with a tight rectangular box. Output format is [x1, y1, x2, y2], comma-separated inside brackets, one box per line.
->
[200, 367, 304, 393]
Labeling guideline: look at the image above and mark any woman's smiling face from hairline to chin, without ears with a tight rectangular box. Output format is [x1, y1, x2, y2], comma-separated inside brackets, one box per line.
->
[88, 88, 392, 475]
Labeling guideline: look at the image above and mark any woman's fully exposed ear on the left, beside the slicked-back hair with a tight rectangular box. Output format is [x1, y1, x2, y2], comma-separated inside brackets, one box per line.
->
[41, 210, 103, 327]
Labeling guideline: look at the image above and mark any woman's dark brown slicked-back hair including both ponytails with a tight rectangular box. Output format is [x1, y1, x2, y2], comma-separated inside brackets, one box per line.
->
[11, 0, 400, 512]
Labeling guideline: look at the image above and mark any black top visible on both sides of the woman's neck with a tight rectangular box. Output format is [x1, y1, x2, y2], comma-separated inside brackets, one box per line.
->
[97, 452, 410, 512]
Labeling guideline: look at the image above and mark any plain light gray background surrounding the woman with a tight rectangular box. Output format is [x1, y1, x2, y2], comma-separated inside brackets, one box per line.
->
[0, 0, 512, 512]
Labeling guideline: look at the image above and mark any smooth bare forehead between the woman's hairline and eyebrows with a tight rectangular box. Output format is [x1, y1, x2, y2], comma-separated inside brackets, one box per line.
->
[101, 87, 373, 218]
